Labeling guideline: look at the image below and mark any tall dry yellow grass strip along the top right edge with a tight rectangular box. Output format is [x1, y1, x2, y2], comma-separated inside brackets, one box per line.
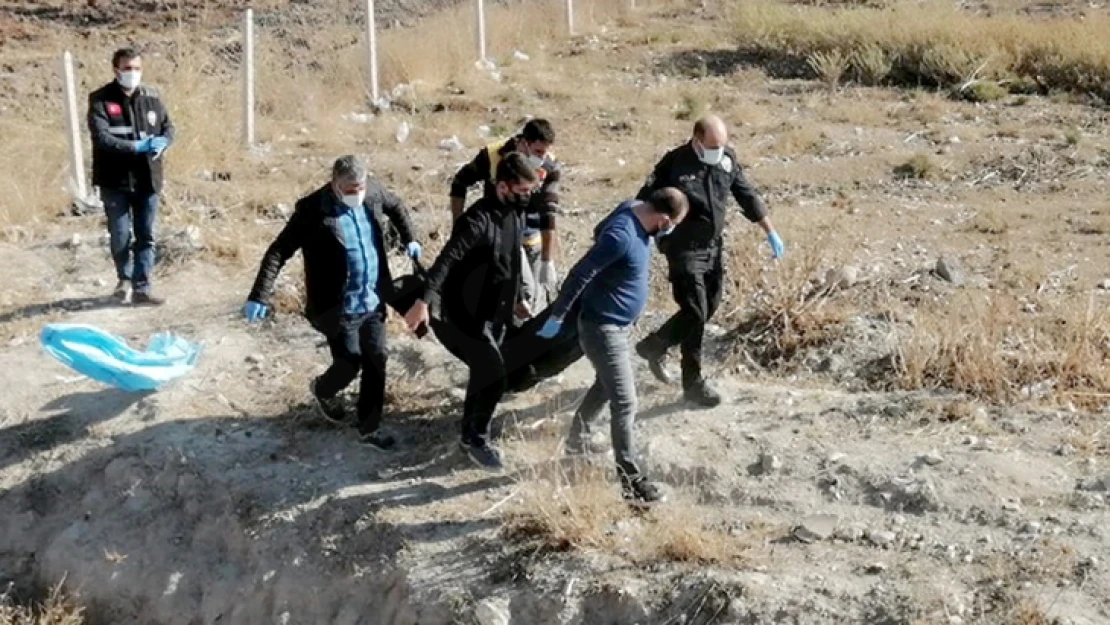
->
[730, 1, 1110, 99]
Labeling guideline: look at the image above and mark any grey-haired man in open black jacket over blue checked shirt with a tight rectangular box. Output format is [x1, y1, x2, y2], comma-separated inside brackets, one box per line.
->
[243, 155, 421, 451]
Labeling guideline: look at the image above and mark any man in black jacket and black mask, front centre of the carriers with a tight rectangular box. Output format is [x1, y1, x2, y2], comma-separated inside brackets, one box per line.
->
[405, 152, 538, 470]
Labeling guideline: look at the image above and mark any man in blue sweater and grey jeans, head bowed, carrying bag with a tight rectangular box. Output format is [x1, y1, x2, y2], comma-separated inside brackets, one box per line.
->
[539, 188, 689, 504]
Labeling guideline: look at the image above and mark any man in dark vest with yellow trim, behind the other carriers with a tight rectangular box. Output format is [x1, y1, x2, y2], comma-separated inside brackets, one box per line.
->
[451, 119, 563, 311]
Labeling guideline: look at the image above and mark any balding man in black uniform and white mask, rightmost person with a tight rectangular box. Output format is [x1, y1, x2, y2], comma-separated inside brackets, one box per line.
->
[636, 115, 784, 407]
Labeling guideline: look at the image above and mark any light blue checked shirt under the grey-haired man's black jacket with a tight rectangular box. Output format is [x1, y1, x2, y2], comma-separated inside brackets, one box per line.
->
[334, 201, 381, 316]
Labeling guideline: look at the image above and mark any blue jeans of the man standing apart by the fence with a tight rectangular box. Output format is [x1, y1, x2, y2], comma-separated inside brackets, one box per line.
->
[100, 189, 158, 293]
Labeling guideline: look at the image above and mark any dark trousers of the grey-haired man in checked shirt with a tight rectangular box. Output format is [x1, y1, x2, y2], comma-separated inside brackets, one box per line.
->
[316, 309, 387, 434]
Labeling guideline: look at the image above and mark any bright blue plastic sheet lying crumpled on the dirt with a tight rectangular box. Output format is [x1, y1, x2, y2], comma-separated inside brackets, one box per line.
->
[39, 323, 201, 392]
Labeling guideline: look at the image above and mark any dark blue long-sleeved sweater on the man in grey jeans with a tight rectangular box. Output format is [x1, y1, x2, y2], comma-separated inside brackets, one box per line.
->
[552, 200, 652, 325]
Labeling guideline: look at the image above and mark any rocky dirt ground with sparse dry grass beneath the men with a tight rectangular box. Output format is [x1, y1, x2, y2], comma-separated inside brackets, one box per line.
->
[0, 3, 1110, 625]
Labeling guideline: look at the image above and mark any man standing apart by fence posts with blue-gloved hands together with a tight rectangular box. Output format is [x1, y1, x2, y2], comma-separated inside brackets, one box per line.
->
[88, 48, 173, 305]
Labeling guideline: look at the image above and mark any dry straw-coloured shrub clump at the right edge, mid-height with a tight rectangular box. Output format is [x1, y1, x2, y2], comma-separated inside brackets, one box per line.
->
[896, 294, 1110, 405]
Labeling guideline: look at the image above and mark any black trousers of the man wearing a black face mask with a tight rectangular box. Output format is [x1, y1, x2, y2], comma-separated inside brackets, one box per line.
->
[434, 321, 506, 445]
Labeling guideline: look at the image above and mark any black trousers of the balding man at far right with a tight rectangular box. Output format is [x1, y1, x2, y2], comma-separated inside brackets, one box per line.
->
[640, 243, 725, 389]
